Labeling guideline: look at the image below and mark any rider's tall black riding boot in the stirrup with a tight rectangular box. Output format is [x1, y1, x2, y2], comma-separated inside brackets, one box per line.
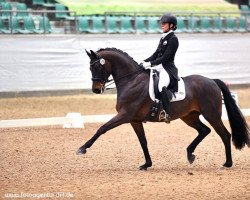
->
[160, 87, 172, 123]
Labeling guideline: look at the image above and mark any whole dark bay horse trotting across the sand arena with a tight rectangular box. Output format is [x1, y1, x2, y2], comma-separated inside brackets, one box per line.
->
[77, 48, 250, 170]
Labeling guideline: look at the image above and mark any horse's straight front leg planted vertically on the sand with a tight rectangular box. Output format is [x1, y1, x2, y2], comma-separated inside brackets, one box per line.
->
[131, 122, 152, 170]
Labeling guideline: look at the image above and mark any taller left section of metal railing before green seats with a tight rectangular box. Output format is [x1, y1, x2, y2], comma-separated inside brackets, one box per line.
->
[0, 10, 78, 34]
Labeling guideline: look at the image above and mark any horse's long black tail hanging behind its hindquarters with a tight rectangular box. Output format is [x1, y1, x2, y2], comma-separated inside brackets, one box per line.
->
[214, 79, 250, 149]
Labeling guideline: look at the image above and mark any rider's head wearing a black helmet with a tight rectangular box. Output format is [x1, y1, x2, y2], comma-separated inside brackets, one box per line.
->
[160, 14, 177, 33]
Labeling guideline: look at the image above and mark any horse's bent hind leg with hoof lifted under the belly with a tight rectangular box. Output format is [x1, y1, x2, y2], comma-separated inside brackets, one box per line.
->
[181, 112, 211, 164]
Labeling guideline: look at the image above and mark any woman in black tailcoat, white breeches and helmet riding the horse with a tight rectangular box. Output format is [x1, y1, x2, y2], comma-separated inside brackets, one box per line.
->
[142, 14, 179, 122]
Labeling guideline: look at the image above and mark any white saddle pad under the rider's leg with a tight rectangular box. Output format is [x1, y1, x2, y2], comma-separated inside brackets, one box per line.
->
[149, 70, 186, 102]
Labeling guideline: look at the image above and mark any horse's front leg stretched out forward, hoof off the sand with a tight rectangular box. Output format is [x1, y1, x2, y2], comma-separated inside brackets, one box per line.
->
[76, 112, 131, 155]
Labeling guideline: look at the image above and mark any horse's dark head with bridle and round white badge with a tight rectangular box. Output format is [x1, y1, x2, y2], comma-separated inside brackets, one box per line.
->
[86, 50, 110, 94]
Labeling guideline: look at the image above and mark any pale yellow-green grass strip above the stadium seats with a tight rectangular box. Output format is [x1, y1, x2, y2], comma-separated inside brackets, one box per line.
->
[55, 0, 238, 15]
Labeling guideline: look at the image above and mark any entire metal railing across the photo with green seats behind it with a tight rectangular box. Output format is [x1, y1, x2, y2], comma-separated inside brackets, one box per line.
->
[0, 10, 250, 34]
